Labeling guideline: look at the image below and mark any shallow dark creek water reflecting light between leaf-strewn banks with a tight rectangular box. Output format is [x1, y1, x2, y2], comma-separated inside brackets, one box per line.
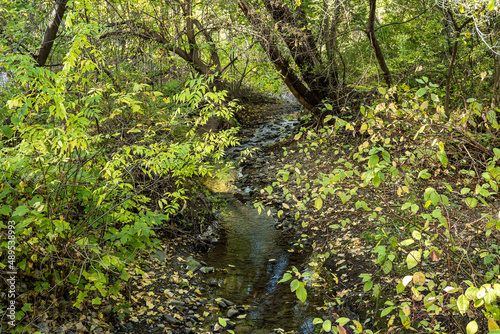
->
[203, 108, 318, 334]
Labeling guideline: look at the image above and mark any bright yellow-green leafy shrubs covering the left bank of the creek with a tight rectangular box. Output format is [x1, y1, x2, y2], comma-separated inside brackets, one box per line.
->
[0, 28, 237, 332]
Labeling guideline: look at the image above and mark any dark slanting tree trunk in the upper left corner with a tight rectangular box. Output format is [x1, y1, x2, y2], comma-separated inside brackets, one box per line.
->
[33, 0, 68, 67]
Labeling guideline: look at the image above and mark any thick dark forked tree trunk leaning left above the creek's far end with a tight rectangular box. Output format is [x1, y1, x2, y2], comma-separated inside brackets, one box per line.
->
[237, 0, 338, 116]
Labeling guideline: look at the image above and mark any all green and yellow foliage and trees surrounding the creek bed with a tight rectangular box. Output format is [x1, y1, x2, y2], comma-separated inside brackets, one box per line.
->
[0, 0, 500, 333]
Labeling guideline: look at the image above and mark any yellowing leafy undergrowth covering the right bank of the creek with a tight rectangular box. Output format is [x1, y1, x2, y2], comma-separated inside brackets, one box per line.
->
[272, 78, 500, 333]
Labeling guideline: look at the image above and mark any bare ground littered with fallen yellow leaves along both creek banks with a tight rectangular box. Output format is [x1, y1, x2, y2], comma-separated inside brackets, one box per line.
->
[48, 101, 494, 334]
